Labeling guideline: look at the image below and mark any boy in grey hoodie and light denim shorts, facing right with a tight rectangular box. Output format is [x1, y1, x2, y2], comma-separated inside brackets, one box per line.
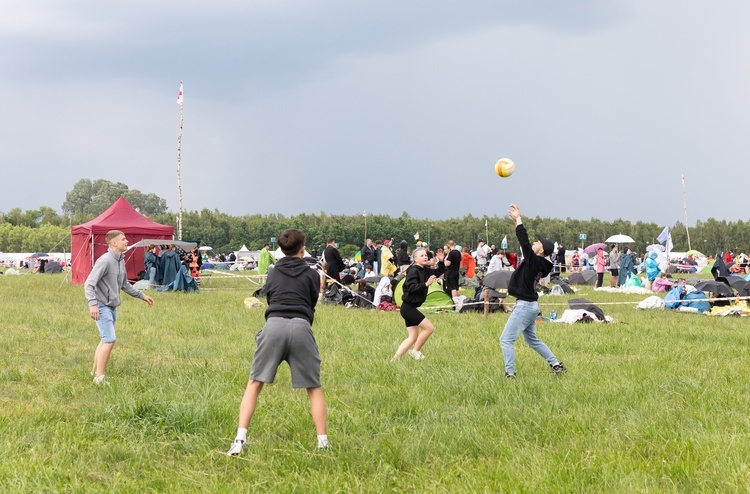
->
[83, 230, 154, 384]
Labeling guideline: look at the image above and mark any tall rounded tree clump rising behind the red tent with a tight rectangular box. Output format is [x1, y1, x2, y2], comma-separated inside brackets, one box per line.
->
[62, 178, 167, 218]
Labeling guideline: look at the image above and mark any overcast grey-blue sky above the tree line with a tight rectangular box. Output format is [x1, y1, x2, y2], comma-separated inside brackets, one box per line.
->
[0, 0, 750, 225]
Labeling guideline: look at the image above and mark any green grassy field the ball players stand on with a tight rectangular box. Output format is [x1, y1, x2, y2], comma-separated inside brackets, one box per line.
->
[0, 275, 750, 493]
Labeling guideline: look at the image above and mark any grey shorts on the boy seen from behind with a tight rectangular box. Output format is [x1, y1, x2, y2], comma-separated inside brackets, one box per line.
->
[250, 317, 320, 388]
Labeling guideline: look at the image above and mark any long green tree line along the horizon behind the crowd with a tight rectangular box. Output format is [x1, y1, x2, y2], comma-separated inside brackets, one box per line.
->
[0, 179, 750, 256]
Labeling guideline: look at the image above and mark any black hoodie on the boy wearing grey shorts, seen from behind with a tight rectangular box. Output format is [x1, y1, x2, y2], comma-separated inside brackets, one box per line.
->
[266, 257, 320, 325]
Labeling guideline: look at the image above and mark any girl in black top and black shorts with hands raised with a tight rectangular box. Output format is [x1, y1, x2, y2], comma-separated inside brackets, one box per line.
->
[391, 249, 445, 362]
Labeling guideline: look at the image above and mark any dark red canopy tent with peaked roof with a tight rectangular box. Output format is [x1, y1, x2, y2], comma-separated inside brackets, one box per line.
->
[70, 196, 174, 285]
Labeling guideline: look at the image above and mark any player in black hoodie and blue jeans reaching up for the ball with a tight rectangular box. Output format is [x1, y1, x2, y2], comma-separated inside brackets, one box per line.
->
[500, 204, 567, 379]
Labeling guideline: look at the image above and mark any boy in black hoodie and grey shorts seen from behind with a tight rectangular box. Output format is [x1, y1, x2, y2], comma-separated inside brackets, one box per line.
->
[227, 228, 329, 456]
